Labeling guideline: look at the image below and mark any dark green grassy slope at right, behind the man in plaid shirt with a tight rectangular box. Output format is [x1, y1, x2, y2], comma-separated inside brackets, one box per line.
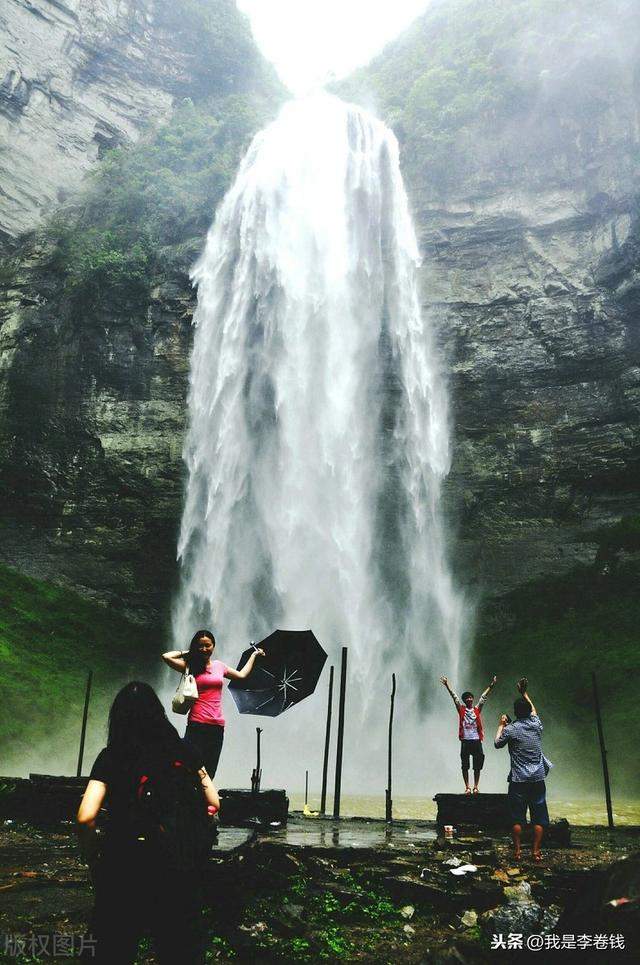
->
[474, 564, 640, 797]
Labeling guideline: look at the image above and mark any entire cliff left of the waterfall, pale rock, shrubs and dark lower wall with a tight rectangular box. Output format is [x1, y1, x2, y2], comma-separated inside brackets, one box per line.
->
[0, 0, 280, 624]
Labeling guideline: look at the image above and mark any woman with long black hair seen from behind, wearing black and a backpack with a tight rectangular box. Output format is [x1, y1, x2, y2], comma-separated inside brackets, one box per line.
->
[77, 681, 220, 965]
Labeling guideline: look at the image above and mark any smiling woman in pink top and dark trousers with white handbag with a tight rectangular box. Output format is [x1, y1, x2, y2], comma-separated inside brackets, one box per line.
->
[162, 630, 264, 777]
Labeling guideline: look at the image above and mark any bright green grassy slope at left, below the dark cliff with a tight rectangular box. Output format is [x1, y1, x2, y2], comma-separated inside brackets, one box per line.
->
[0, 566, 161, 774]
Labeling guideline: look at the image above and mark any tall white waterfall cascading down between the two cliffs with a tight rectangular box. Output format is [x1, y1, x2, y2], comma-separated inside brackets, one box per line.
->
[174, 94, 464, 786]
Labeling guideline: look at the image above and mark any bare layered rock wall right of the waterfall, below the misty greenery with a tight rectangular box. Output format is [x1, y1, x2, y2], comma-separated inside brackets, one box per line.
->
[418, 163, 640, 593]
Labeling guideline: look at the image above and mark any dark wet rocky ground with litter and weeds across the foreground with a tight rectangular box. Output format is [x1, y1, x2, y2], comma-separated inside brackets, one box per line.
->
[0, 816, 640, 965]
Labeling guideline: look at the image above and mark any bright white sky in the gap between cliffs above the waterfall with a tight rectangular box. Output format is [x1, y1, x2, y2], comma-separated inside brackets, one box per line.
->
[237, 0, 430, 94]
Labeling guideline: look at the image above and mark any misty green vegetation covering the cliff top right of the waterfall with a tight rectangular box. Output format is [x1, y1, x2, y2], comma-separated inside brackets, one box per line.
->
[337, 0, 638, 190]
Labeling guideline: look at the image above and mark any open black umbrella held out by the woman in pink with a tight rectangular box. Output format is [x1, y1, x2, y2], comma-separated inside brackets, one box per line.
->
[229, 630, 327, 717]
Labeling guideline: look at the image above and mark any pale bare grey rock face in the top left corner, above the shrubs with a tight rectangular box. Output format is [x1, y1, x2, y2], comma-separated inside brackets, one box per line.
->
[0, 0, 264, 238]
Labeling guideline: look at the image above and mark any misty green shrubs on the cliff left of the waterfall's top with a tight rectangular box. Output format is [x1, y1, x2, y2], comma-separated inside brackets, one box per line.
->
[46, 95, 282, 308]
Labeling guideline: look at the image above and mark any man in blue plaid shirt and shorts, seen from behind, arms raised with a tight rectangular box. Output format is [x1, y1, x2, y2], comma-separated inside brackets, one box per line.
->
[494, 677, 552, 861]
